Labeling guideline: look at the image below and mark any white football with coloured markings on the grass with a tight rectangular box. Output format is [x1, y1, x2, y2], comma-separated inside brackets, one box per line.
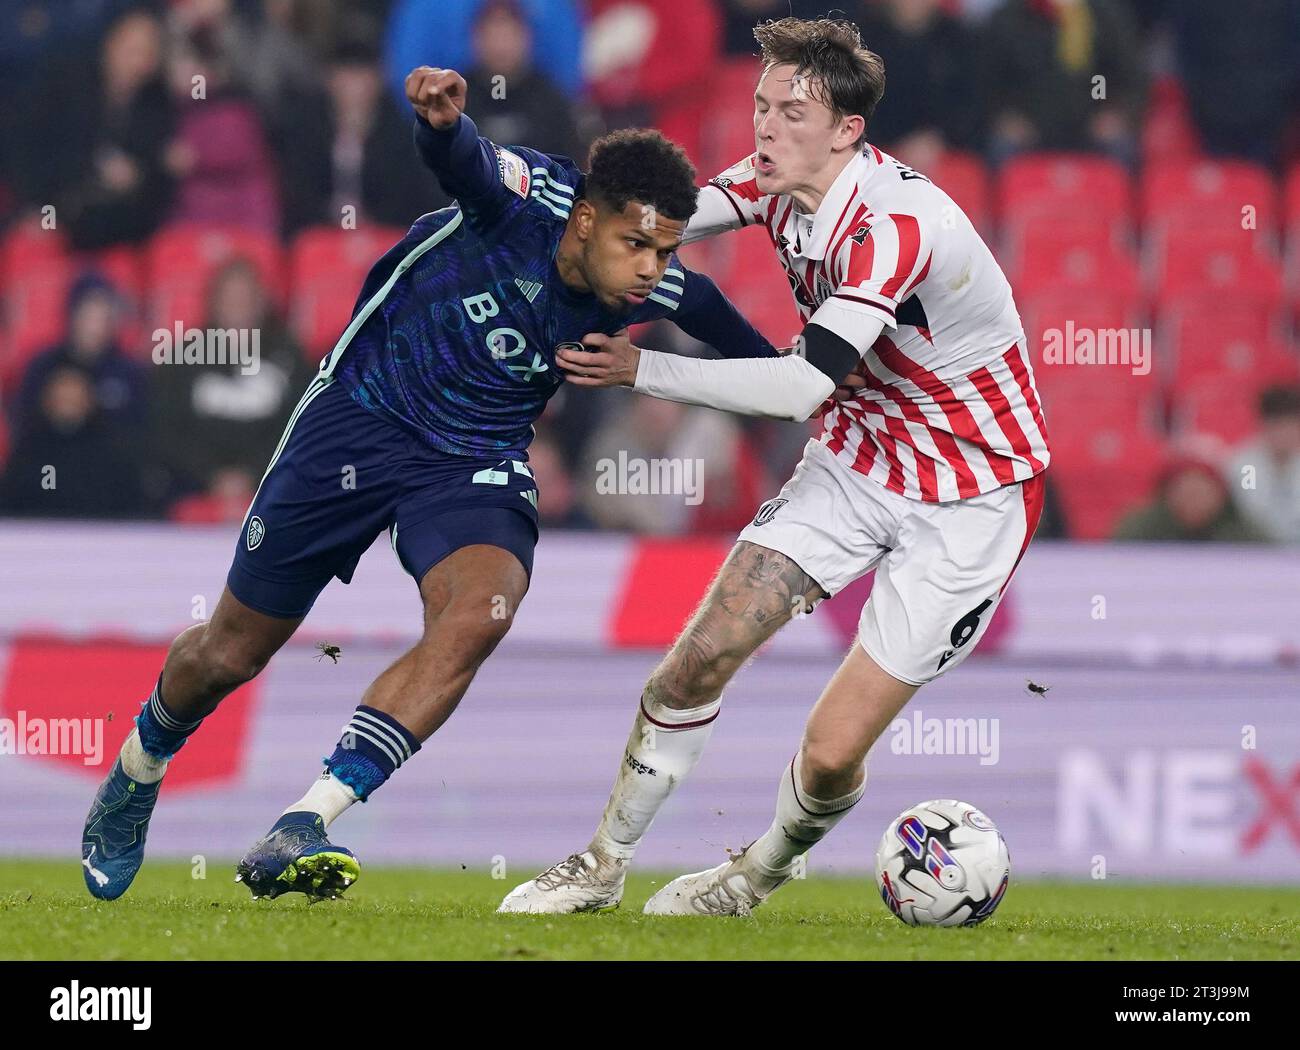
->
[876, 798, 1011, 927]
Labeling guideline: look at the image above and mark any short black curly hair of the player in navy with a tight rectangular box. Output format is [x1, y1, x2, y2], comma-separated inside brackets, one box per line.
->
[584, 127, 699, 222]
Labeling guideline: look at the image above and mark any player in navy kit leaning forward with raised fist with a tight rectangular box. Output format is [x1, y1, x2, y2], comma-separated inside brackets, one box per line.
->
[82, 66, 776, 899]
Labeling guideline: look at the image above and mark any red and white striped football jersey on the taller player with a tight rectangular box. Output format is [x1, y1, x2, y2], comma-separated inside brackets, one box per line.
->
[685, 144, 1048, 503]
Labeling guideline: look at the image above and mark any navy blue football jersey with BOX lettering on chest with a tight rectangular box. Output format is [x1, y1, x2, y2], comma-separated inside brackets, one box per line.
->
[321, 116, 776, 460]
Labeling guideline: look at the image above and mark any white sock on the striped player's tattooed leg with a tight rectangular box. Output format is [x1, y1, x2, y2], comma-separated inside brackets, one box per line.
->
[592, 695, 723, 864]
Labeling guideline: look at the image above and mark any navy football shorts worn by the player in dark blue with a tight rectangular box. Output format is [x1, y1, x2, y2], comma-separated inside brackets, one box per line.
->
[226, 377, 537, 617]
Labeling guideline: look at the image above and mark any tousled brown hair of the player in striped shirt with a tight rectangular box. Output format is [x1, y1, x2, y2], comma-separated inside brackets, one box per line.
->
[754, 18, 885, 147]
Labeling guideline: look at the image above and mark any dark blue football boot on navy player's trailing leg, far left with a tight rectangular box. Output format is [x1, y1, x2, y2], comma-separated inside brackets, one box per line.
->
[82, 759, 163, 901]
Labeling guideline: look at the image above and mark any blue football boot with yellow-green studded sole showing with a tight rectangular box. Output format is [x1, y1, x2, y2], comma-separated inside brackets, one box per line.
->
[235, 812, 361, 901]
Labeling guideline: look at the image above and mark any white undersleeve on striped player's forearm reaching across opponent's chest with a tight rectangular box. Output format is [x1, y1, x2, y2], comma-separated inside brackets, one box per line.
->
[633, 350, 835, 421]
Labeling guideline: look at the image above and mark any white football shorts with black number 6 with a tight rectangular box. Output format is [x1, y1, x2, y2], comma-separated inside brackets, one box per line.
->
[738, 438, 1043, 685]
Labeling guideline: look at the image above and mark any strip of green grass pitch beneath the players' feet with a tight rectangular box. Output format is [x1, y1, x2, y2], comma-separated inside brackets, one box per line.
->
[0, 858, 1300, 960]
